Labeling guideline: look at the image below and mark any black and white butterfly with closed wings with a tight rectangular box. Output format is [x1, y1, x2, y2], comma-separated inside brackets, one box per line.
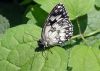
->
[38, 4, 73, 48]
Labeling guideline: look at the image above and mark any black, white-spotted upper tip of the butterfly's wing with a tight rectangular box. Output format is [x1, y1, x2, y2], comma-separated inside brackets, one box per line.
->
[47, 4, 69, 25]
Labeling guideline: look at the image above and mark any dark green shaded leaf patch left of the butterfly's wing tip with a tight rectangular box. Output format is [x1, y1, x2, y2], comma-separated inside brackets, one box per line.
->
[31, 5, 48, 27]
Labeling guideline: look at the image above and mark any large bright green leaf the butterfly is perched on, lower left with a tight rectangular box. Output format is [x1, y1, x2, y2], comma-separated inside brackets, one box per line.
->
[0, 24, 68, 71]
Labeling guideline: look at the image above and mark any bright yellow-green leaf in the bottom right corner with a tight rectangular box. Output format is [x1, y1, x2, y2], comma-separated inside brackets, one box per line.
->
[69, 42, 100, 71]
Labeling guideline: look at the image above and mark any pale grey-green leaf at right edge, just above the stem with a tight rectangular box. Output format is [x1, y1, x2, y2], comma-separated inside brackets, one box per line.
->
[85, 8, 100, 34]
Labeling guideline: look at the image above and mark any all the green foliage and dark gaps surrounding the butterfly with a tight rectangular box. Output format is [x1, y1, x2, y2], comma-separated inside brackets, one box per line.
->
[0, 0, 100, 71]
